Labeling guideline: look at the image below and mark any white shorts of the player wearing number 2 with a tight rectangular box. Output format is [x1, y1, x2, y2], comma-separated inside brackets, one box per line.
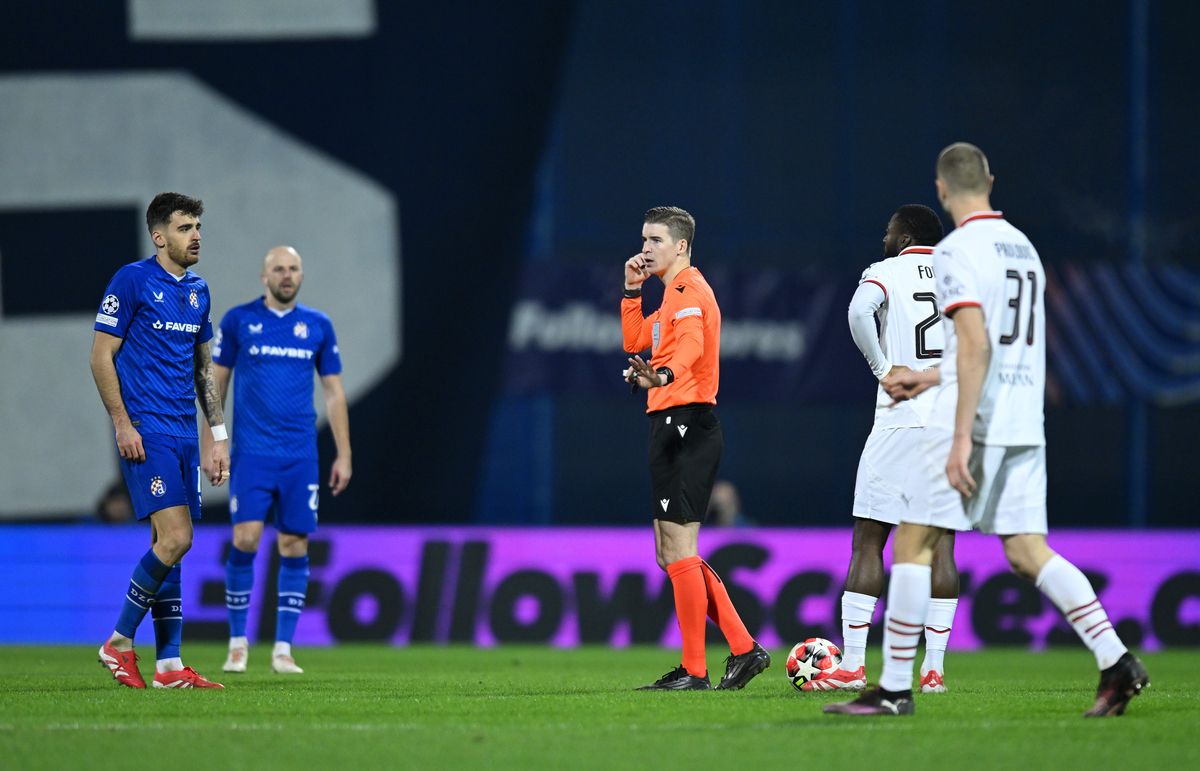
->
[853, 428, 925, 525]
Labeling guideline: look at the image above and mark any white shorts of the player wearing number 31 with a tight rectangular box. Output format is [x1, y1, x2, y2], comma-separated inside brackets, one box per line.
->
[901, 428, 1046, 536]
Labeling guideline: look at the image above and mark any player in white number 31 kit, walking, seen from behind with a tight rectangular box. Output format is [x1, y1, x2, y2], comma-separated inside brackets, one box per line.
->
[826, 143, 1150, 717]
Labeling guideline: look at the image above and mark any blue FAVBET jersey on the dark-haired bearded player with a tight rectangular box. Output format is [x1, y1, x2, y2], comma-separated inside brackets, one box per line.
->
[95, 257, 212, 438]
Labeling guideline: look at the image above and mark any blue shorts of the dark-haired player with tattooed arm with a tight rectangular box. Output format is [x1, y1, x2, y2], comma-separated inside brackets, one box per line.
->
[121, 434, 200, 520]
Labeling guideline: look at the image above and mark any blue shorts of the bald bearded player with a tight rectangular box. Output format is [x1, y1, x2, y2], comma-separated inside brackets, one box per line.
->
[229, 455, 320, 536]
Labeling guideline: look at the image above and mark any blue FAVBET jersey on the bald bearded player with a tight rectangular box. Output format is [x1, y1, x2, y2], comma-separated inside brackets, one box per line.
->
[212, 298, 342, 458]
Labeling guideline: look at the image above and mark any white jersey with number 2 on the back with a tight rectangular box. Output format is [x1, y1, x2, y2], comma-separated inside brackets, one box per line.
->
[859, 246, 946, 429]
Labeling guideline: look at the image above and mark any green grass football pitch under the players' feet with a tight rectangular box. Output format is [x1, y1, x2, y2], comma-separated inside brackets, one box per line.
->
[0, 644, 1200, 771]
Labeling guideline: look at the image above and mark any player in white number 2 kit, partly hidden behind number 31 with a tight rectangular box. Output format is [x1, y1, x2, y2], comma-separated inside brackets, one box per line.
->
[802, 204, 959, 693]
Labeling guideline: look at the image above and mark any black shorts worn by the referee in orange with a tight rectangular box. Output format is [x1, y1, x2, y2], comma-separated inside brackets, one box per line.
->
[649, 405, 725, 522]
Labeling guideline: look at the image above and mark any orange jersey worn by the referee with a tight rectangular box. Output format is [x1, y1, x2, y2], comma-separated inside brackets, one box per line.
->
[620, 267, 721, 412]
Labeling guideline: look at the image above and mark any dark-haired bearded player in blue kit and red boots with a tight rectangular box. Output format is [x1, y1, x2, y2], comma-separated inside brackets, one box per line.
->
[91, 193, 229, 688]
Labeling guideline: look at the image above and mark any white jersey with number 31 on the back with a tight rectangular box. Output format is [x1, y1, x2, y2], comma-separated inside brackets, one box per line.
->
[930, 211, 1046, 447]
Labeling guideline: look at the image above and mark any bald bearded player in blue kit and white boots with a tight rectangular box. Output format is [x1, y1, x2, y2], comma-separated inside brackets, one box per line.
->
[201, 246, 350, 673]
